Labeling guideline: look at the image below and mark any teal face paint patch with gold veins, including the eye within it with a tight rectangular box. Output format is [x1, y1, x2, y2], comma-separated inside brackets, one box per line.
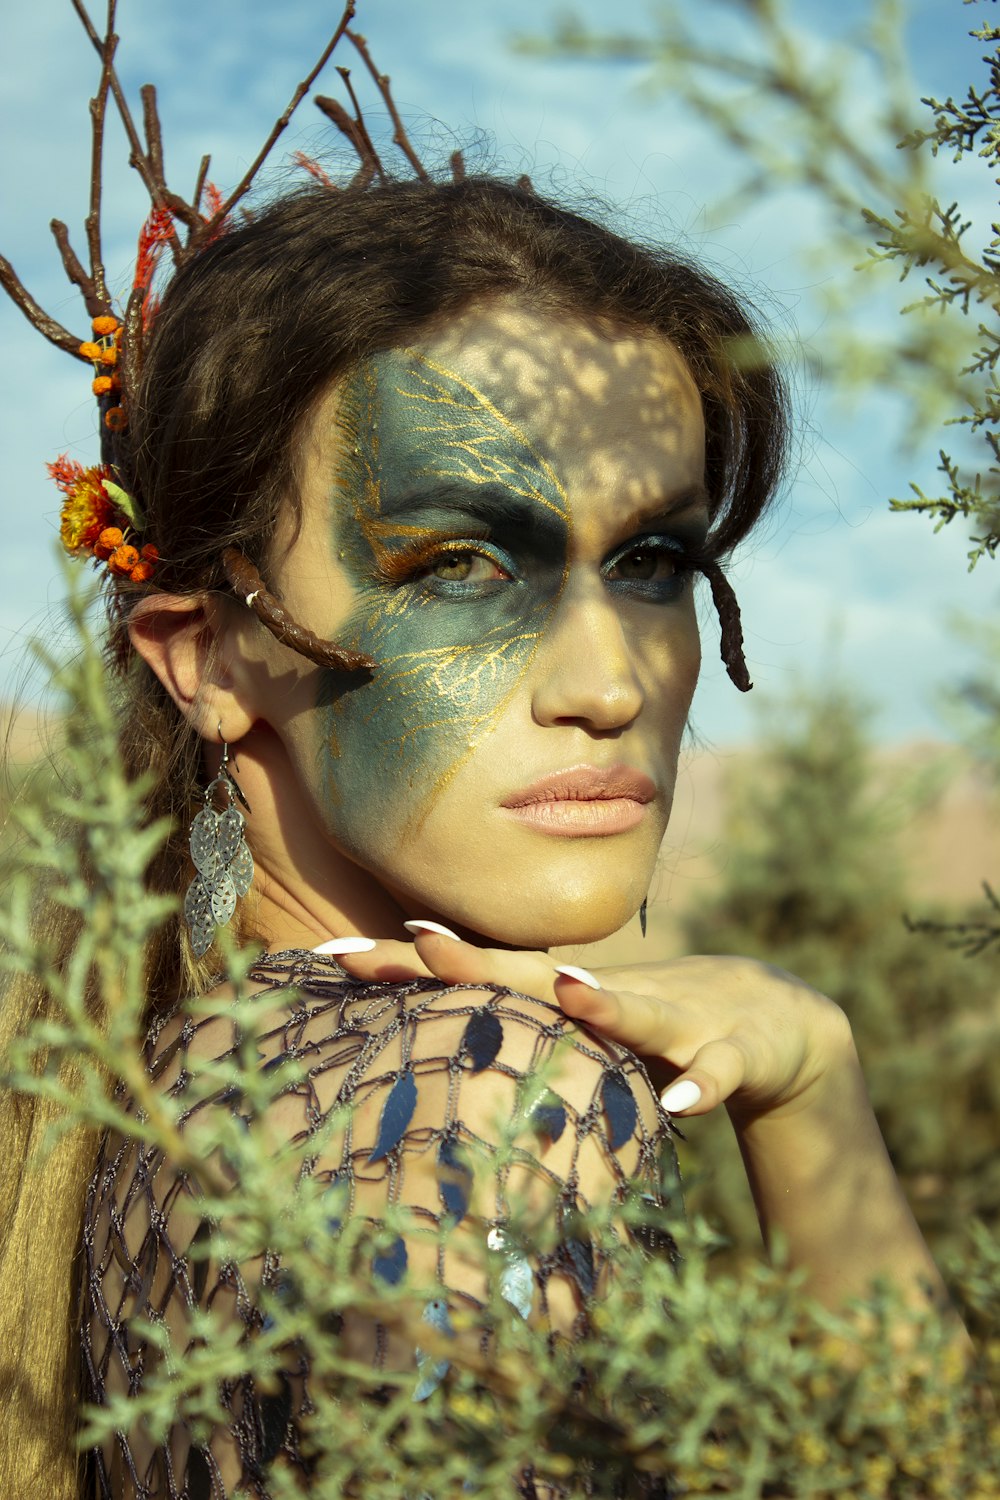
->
[319, 350, 570, 848]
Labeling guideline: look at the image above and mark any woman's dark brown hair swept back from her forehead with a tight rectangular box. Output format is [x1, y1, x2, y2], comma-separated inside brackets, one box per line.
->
[112, 177, 786, 1001]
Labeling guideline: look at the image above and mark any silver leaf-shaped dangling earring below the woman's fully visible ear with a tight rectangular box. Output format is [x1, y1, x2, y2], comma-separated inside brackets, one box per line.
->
[184, 725, 253, 959]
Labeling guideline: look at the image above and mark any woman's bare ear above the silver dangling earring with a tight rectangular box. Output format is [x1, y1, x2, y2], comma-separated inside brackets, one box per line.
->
[129, 594, 258, 744]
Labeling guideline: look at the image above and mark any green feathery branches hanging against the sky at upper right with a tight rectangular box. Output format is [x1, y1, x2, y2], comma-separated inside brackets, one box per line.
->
[519, 0, 1000, 567]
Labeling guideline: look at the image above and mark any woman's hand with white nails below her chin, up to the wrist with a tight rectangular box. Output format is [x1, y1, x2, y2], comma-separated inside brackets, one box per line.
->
[326, 930, 853, 1122]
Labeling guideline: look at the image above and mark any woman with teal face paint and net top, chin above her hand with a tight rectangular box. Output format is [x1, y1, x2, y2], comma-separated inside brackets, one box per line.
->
[0, 29, 940, 1497]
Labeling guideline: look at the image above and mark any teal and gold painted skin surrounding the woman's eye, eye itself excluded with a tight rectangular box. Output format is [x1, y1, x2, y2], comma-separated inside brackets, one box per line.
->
[316, 353, 568, 851]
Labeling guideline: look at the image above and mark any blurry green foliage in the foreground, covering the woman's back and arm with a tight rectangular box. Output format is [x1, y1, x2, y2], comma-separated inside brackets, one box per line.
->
[0, 570, 1000, 1500]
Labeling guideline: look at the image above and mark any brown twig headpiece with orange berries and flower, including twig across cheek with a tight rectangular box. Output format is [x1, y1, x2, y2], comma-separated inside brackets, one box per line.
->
[0, 0, 463, 672]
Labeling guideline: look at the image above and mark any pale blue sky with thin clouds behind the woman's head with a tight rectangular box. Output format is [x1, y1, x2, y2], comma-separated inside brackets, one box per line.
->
[0, 0, 1000, 746]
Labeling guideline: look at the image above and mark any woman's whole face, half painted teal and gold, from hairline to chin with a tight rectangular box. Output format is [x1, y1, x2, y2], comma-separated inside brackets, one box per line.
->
[268, 302, 708, 947]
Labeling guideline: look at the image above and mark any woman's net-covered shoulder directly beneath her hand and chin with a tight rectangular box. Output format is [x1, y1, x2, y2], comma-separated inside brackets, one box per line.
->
[105, 950, 672, 1202]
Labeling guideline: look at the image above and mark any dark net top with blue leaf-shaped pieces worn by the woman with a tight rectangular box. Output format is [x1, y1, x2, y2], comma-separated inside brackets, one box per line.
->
[82, 950, 676, 1500]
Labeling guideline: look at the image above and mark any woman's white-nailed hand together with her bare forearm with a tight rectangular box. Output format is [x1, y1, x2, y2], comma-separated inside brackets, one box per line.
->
[332, 924, 945, 1307]
